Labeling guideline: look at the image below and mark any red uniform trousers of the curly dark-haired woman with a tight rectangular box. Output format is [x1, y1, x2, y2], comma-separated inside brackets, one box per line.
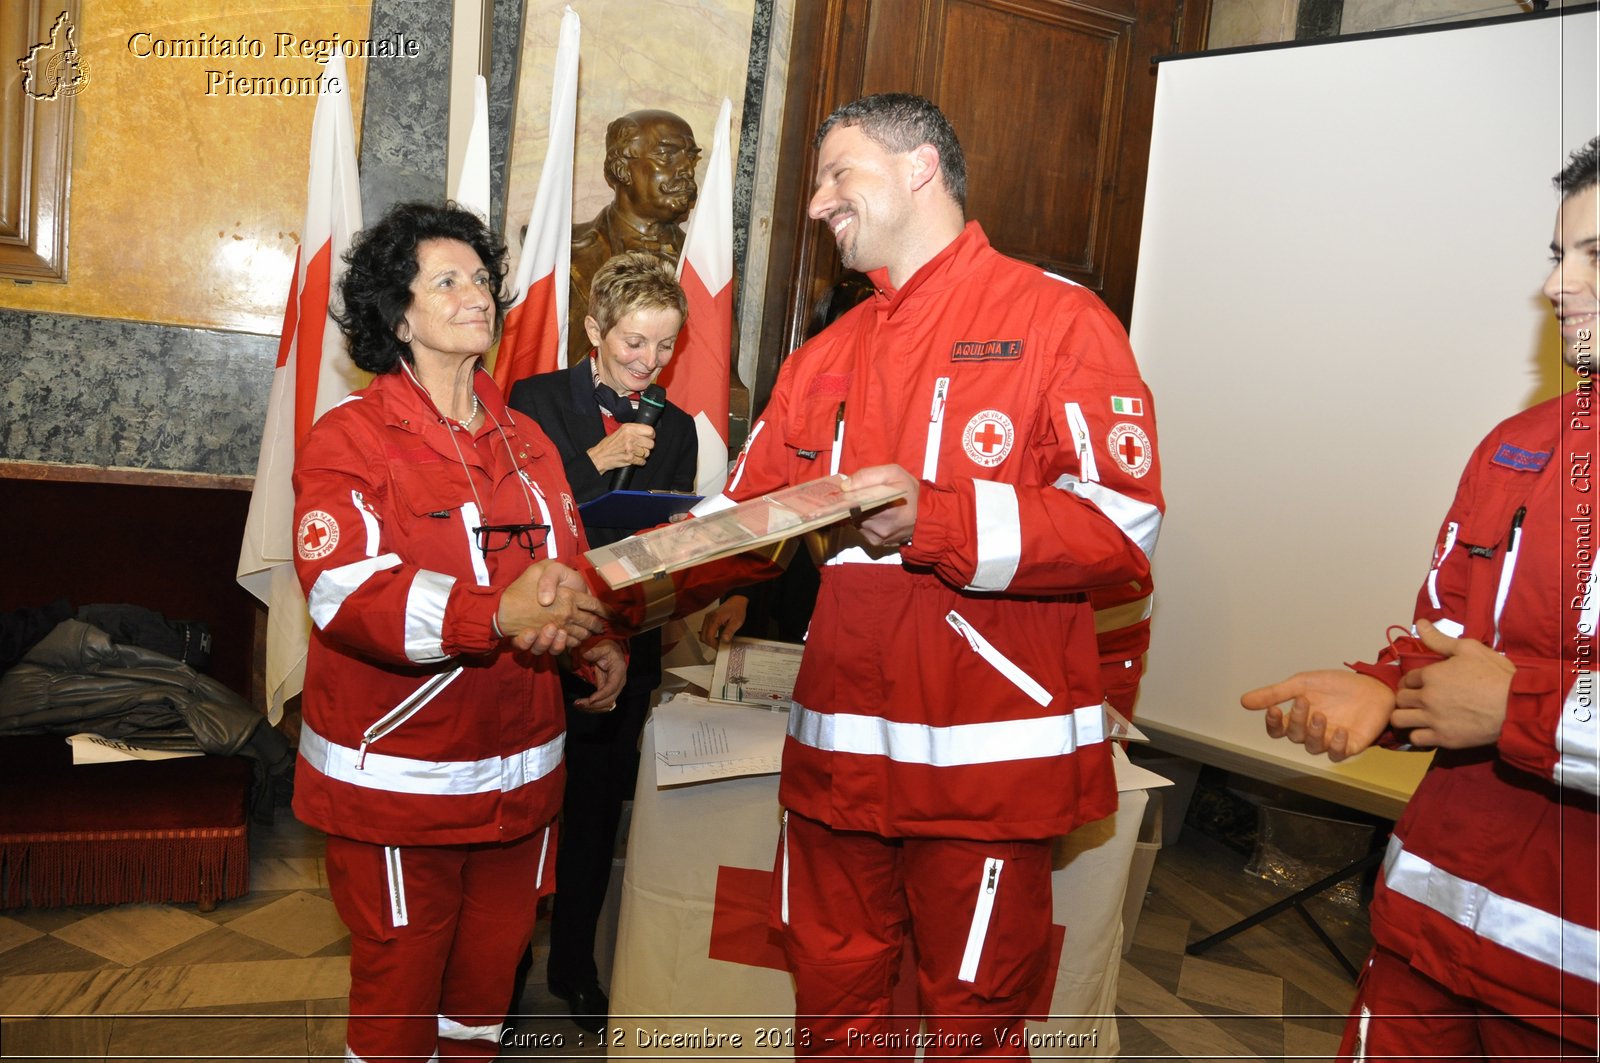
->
[328, 823, 555, 1063]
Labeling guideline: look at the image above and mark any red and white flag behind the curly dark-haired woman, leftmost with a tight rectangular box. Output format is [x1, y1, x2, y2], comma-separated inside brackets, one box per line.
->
[237, 53, 370, 724]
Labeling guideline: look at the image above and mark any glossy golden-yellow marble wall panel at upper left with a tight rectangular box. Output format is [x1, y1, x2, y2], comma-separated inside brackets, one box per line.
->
[0, 0, 371, 335]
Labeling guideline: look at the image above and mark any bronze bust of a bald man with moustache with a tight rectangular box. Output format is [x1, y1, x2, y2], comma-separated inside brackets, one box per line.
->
[566, 110, 701, 363]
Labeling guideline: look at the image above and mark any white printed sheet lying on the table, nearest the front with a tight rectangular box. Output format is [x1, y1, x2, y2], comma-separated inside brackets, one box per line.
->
[654, 693, 789, 789]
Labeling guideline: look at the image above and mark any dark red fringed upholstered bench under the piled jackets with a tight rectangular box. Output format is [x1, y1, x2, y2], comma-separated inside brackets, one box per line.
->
[0, 735, 250, 909]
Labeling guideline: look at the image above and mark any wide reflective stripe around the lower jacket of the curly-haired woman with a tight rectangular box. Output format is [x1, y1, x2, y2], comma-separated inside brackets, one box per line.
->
[299, 725, 566, 797]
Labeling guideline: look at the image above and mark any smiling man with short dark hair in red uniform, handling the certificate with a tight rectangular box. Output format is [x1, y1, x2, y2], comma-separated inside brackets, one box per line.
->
[699, 94, 1162, 1057]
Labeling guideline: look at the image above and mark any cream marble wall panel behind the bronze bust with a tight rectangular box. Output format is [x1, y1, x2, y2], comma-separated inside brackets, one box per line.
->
[506, 0, 755, 259]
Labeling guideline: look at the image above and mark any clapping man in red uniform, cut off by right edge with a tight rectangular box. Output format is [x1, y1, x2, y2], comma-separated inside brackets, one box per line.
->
[1242, 138, 1600, 1060]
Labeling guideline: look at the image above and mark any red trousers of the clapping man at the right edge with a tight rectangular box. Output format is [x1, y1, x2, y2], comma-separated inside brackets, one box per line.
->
[1339, 948, 1595, 1061]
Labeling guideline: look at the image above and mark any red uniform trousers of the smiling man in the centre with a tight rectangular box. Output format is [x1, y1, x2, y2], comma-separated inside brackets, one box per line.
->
[773, 812, 1051, 1058]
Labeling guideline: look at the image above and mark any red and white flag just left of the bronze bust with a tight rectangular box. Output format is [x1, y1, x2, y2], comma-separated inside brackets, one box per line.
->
[494, 8, 579, 394]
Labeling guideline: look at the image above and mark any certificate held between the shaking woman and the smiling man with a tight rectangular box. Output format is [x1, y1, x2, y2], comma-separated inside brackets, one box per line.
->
[586, 475, 906, 591]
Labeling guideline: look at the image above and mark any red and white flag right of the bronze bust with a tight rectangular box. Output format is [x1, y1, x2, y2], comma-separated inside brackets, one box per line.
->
[661, 98, 733, 496]
